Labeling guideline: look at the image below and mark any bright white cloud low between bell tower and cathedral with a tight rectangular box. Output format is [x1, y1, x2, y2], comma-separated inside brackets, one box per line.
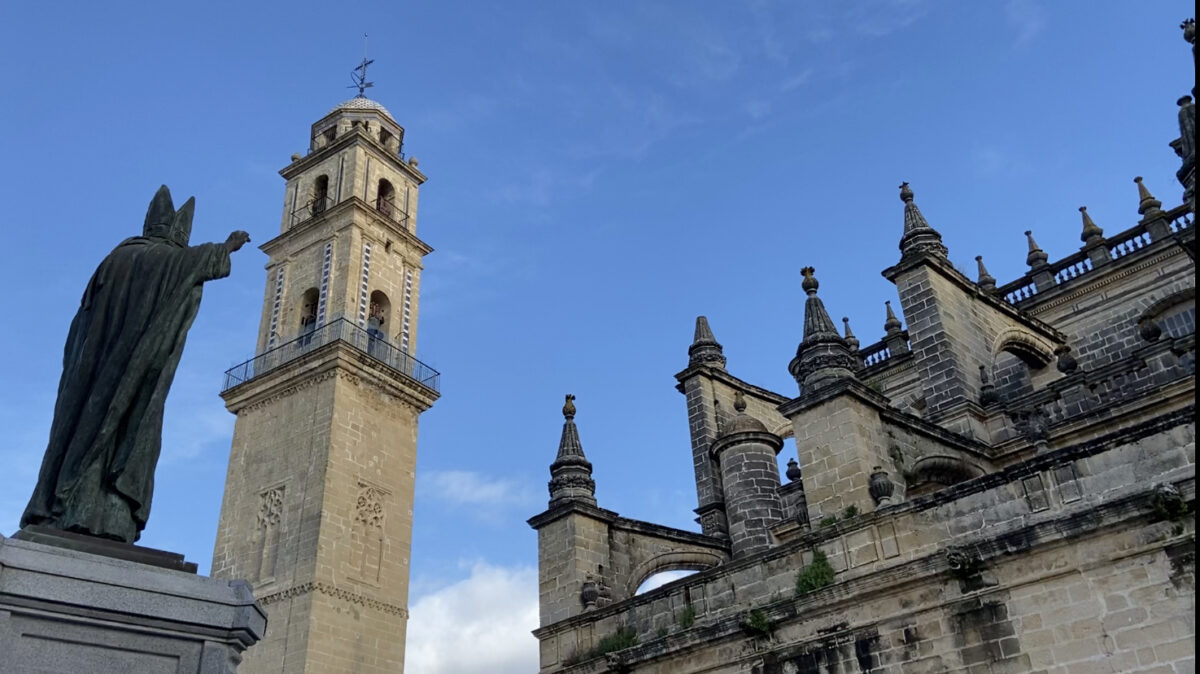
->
[404, 561, 538, 674]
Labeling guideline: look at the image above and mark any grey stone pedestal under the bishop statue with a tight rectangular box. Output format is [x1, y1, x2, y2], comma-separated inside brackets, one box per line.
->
[0, 536, 266, 674]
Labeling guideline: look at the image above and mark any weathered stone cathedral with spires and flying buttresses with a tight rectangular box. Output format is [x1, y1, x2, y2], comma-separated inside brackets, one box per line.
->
[530, 19, 1195, 674]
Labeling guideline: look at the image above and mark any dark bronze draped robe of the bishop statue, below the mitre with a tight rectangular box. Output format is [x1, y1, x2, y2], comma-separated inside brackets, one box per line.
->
[20, 236, 229, 543]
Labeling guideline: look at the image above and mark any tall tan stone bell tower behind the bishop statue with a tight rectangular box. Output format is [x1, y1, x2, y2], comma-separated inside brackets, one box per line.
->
[212, 90, 438, 673]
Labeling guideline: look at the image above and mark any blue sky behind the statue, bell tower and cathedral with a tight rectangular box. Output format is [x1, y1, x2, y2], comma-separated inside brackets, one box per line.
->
[0, 0, 1194, 674]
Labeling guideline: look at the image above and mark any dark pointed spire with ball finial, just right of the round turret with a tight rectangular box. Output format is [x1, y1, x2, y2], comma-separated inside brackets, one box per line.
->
[787, 266, 862, 393]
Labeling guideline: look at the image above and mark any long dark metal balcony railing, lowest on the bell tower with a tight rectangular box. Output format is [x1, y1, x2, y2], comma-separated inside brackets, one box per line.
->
[221, 318, 442, 392]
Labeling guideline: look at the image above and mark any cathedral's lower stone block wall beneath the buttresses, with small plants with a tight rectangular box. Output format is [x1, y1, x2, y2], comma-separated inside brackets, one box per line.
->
[536, 410, 1195, 674]
